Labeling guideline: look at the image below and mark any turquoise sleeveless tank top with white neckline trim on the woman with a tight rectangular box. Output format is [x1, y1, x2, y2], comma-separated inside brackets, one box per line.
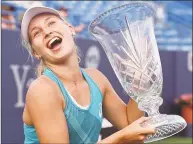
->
[24, 68, 103, 144]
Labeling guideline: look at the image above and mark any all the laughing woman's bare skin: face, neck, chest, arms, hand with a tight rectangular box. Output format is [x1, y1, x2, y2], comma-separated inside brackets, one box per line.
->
[23, 13, 155, 143]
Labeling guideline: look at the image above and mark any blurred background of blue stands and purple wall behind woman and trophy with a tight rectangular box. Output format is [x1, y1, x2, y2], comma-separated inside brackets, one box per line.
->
[1, 1, 192, 144]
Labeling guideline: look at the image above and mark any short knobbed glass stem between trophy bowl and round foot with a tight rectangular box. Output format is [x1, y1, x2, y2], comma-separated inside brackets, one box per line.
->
[138, 96, 163, 116]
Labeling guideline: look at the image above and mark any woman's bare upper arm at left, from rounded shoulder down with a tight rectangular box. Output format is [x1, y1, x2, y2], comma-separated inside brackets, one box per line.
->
[26, 77, 69, 143]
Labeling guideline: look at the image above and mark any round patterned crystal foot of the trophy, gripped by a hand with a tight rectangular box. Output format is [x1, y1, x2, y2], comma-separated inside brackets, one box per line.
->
[142, 114, 187, 143]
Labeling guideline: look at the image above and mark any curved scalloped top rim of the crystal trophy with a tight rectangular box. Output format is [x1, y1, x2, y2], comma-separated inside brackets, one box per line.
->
[88, 2, 155, 34]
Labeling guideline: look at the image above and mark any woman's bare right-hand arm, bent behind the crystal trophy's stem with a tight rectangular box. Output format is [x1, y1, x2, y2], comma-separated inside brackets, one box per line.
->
[88, 69, 144, 129]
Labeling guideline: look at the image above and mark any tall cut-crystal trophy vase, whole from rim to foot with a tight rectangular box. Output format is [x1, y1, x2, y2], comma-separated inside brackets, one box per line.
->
[89, 2, 187, 143]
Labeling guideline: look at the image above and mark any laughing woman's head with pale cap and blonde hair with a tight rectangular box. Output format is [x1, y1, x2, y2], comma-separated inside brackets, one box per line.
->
[22, 7, 77, 76]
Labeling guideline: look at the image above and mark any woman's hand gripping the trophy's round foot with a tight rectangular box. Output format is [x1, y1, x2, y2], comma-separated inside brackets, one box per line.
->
[122, 117, 155, 144]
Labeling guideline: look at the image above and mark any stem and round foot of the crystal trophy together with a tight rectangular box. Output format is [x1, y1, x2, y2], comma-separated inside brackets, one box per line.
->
[138, 96, 187, 143]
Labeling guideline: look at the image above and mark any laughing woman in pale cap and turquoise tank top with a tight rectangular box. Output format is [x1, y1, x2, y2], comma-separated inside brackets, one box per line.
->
[21, 7, 155, 143]
